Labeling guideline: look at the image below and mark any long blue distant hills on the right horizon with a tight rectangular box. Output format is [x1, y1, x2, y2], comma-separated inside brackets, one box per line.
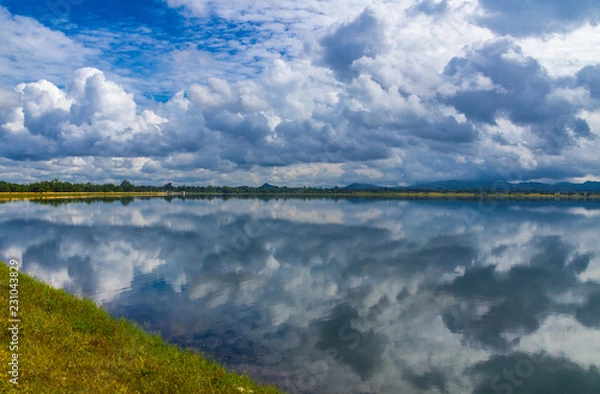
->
[345, 179, 600, 193]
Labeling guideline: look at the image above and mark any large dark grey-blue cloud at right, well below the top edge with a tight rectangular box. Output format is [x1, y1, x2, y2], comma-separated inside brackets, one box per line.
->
[442, 38, 592, 155]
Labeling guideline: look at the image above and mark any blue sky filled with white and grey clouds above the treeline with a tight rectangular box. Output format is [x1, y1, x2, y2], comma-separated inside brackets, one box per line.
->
[0, 0, 600, 186]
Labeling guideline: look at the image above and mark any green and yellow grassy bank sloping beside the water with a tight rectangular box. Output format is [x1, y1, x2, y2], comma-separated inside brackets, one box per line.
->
[0, 263, 279, 394]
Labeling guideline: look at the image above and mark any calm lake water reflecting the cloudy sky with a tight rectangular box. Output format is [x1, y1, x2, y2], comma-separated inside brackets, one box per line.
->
[0, 199, 600, 394]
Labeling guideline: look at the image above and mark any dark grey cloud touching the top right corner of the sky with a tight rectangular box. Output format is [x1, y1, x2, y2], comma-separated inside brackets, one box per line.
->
[479, 0, 600, 36]
